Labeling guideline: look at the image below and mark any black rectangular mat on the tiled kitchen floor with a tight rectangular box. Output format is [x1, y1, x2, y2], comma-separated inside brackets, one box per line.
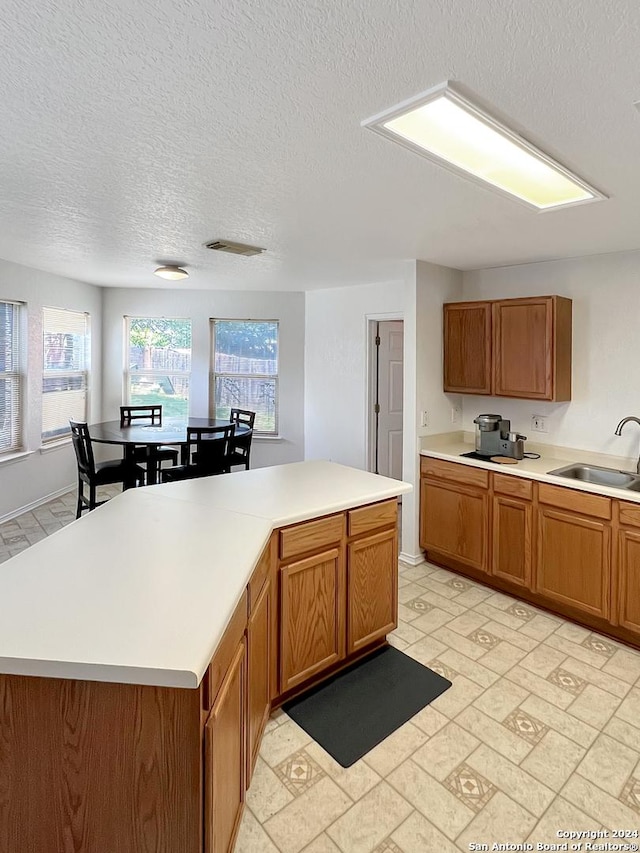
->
[283, 646, 451, 767]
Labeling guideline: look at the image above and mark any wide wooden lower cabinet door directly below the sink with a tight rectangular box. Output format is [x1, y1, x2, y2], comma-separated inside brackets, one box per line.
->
[536, 506, 611, 619]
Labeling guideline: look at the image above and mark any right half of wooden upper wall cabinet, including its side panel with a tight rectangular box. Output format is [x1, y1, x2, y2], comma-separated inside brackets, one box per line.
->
[492, 296, 571, 402]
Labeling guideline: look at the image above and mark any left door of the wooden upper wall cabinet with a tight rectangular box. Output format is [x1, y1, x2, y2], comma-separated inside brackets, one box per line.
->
[443, 302, 491, 394]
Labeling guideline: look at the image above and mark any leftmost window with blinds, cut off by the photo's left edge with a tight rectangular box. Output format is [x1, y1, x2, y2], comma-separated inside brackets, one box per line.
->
[0, 302, 22, 453]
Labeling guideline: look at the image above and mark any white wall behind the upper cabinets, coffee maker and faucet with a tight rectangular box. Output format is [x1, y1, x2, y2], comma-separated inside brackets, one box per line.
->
[463, 252, 640, 457]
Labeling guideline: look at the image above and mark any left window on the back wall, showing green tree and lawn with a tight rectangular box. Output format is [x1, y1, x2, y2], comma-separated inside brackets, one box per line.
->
[125, 317, 191, 420]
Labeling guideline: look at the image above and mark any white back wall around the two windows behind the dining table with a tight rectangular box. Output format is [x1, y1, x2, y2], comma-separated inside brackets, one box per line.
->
[102, 286, 305, 468]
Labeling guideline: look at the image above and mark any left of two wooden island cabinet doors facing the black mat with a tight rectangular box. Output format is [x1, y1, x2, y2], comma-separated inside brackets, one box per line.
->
[280, 548, 346, 693]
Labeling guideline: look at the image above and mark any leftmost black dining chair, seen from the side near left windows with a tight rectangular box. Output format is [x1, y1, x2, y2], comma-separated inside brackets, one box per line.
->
[69, 421, 144, 518]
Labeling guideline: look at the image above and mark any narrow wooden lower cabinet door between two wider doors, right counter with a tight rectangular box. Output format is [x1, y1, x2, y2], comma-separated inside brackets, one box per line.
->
[491, 495, 533, 588]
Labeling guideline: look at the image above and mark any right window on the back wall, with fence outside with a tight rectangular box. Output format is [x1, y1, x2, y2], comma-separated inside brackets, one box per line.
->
[210, 320, 278, 435]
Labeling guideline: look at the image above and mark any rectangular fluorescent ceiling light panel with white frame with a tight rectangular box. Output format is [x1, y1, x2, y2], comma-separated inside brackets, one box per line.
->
[362, 84, 606, 210]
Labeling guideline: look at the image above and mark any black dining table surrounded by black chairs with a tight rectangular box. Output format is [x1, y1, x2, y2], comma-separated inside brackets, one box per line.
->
[89, 418, 251, 486]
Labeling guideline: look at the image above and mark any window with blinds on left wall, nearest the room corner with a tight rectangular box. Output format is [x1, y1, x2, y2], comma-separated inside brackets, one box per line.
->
[42, 308, 89, 443]
